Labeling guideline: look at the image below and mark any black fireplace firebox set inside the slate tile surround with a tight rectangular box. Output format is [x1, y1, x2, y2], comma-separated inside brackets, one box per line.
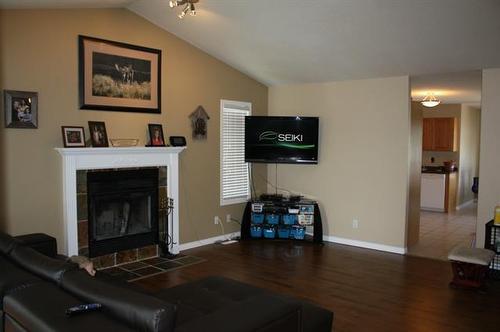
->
[87, 168, 158, 257]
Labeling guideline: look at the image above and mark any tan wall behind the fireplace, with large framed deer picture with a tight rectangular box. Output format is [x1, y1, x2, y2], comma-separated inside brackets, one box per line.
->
[0, 9, 268, 246]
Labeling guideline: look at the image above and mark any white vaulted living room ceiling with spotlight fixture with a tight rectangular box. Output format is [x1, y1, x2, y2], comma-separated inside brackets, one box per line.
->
[0, 0, 500, 92]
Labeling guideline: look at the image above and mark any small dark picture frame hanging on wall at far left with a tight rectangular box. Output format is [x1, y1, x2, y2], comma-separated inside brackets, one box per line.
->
[4, 90, 38, 129]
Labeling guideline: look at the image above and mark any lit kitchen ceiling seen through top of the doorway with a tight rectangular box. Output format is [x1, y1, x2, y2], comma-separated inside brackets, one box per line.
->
[411, 70, 482, 105]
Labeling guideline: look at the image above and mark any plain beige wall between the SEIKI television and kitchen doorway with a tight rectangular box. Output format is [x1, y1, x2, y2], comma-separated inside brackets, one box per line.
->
[268, 77, 410, 248]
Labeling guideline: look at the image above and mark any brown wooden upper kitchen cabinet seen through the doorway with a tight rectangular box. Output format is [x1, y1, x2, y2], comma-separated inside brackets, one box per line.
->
[422, 118, 458, 151]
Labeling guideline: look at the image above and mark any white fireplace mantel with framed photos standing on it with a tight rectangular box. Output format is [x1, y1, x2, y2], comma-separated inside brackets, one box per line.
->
[55, 147, 185, 256]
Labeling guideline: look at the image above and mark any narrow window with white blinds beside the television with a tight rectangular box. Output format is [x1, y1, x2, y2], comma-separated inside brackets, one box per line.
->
[220, 100, 252, 205]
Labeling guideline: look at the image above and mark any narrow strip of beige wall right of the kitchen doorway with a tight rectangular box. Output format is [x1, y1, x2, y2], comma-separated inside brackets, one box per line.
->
[476, 68, 500, 247]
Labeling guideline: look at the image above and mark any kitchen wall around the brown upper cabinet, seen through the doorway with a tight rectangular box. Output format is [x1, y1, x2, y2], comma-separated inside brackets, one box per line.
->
[422, 104, 461, 166]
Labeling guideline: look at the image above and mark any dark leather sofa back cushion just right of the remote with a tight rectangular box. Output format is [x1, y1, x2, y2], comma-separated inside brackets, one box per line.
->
[61, 270, 176, 331]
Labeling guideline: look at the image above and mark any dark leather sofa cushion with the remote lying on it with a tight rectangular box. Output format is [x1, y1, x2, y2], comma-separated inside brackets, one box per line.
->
[4, 281, 133, 332]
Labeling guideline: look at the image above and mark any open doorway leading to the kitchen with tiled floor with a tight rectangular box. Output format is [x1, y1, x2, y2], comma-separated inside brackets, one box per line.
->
[407, 71, 482, 260]
